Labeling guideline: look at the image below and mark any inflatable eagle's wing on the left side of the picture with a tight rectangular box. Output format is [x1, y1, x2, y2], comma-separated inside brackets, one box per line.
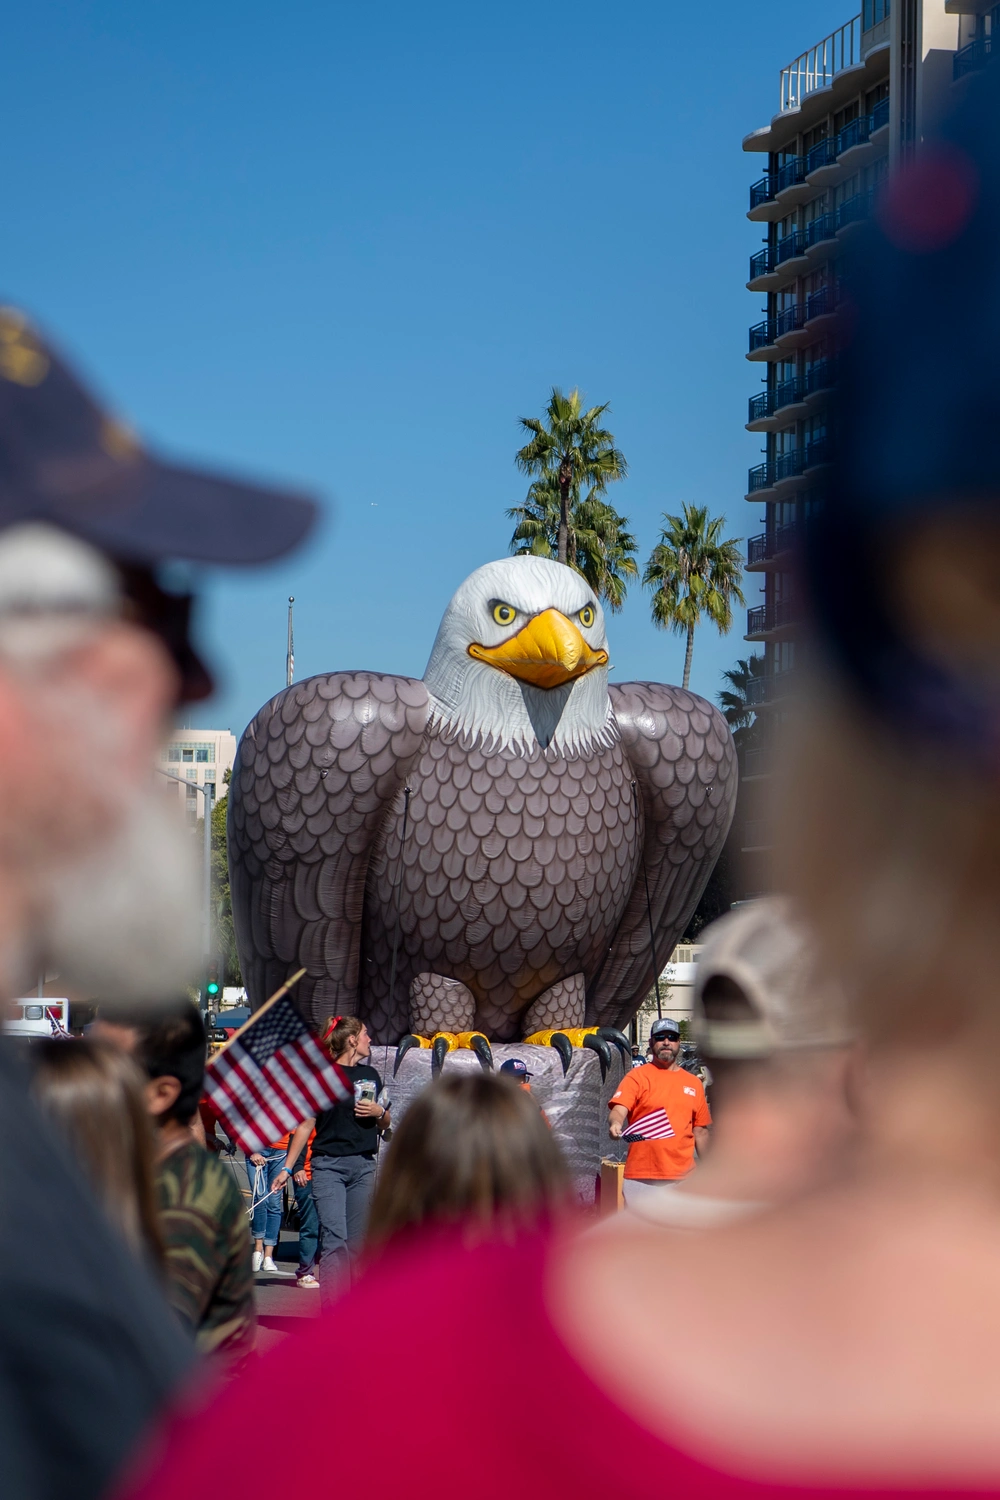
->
[226, 672, 427, 1023]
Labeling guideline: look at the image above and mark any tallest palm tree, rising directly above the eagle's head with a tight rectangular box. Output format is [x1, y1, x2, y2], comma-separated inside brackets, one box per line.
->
[514, 386, 628, 563]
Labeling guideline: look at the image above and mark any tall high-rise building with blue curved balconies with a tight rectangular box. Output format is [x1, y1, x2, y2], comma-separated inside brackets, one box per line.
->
[739, 0, 1000, 896]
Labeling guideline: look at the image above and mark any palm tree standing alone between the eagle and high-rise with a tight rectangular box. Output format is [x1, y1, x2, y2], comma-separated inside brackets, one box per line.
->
[642, 501, 745, 687]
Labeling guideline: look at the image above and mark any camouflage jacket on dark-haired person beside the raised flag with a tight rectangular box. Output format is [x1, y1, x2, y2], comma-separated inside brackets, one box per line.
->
[156, 1140, 256, 1365]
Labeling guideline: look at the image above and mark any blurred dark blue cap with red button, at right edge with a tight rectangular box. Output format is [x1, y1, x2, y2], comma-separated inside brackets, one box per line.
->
[804, 68, 1000, 750]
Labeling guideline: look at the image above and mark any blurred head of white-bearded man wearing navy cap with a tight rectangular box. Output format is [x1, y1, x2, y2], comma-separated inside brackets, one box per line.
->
[0, 306, 313, 996]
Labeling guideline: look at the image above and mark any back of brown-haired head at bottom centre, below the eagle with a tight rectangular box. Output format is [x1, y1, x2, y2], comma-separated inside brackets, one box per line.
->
[367, 1071, 568, 1251]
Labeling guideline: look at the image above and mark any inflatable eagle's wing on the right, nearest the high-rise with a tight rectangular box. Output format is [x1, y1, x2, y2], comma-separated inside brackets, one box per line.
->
[586, 683, 736, 1026]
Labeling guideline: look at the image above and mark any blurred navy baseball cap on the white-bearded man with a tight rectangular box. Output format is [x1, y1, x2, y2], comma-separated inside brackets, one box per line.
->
[0, 305, 316, 564]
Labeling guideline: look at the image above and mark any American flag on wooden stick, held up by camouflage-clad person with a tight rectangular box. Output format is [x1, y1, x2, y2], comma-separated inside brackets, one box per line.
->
[205, 990, 354, 1154]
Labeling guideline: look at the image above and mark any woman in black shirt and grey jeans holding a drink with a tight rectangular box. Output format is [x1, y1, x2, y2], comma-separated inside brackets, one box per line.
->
[276, 1016, 391, 1302]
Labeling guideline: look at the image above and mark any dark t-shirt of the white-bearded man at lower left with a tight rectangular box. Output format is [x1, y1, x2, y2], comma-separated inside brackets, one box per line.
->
[0, 1041, 193, 1500]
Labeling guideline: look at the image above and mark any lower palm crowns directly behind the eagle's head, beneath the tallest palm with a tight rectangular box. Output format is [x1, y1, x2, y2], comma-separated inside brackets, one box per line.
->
[507, 474, 639, 614]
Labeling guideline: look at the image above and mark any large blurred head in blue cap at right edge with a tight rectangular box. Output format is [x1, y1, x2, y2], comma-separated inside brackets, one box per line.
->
[786, 72, 1000, 1068]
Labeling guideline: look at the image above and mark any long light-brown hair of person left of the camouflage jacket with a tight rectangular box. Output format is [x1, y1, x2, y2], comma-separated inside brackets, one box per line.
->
[31, 1041, 162, 1260]
